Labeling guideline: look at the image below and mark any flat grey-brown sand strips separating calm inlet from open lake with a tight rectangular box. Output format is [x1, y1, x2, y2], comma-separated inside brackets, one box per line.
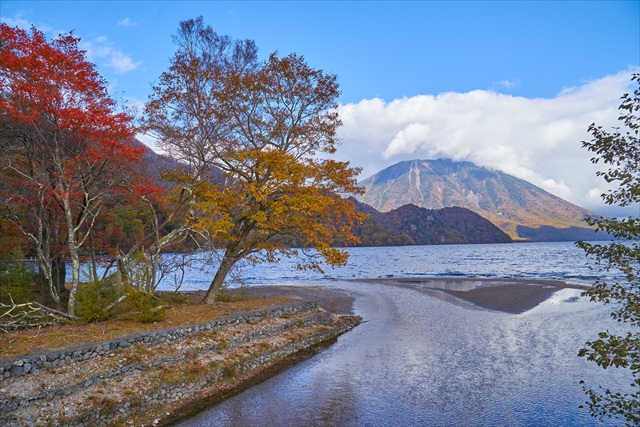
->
[219, 277, 588, 314]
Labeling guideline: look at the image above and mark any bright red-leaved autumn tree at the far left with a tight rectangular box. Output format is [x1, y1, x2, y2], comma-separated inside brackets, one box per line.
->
[0, 24, 143, 316]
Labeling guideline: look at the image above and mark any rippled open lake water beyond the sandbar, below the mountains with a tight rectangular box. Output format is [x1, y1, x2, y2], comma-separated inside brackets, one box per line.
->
[159, 242, 598, 290]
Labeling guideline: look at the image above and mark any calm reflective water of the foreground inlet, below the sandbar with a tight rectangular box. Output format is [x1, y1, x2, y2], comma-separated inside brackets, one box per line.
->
[175, 282, 624, 426]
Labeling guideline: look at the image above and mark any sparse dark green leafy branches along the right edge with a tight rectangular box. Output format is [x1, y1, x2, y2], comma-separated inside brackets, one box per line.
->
[578, 74, 640, 425]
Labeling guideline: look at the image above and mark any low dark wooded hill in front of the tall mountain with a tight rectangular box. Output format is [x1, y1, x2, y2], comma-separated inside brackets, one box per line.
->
[351, 198, 512, 246]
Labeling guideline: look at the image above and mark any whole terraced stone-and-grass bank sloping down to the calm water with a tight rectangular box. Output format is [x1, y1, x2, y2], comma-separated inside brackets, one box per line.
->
[0, 298, 361, 427]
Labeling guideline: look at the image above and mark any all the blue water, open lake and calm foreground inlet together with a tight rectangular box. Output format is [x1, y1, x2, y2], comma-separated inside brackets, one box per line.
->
[164, 243, 627, 427]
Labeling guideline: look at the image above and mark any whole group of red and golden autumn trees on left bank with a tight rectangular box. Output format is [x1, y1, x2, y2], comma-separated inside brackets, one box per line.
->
[0, 18, 366, 317]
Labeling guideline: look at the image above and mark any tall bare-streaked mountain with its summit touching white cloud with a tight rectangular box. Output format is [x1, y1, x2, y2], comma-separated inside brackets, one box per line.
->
[358, 159, 606, 241]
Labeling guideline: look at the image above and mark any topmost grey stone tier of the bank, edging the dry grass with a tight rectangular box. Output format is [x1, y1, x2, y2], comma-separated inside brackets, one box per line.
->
[0, 301, 318, 383]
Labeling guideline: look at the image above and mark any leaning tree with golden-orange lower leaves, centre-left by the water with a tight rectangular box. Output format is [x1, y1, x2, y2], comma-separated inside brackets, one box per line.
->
[145, 17, 362, 303]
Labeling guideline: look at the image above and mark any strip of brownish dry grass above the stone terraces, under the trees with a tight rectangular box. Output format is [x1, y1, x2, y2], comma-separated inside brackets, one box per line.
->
[0, 297, 292, 360]
